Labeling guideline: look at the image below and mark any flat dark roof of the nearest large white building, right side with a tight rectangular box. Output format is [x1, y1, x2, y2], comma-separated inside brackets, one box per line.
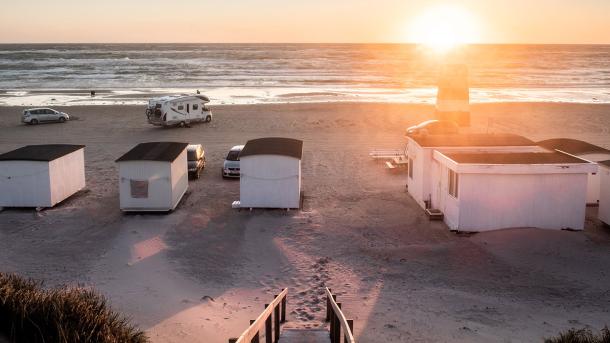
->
[445, 152, 589, 164]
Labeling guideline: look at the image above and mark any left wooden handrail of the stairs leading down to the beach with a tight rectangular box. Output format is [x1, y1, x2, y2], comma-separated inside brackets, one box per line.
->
[229, 288, 288, 343]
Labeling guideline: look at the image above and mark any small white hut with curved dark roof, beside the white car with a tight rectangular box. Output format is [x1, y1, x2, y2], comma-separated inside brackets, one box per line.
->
[239, 137, 303, 209]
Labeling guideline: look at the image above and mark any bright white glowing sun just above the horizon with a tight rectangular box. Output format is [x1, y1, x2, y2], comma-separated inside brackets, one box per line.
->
[409, 5, 477, 53]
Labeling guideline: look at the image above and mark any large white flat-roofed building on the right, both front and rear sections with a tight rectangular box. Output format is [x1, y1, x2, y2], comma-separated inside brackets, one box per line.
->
[407, 134, 597, 231]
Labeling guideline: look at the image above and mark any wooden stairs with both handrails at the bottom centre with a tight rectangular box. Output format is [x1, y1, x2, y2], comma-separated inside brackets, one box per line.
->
[229, 287, 356, 343]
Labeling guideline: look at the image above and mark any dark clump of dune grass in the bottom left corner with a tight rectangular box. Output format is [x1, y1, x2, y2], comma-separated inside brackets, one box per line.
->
[0, 273, 148, 343]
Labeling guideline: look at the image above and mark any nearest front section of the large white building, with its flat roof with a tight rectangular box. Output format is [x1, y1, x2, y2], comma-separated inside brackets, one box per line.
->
[431, 151, 597, 231]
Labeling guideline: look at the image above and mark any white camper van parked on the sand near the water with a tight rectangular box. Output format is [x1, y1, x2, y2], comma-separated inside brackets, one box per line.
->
[146, 94, 212, 126]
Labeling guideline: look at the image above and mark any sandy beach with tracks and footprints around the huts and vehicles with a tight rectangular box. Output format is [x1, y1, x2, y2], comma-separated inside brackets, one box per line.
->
[0, 103, 610, 342]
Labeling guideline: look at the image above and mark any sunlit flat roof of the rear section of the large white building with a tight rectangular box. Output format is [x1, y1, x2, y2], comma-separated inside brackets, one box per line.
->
[410, 133, 536, 147]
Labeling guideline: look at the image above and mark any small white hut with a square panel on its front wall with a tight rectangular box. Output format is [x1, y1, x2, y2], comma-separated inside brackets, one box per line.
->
[116, 142, 188, 211]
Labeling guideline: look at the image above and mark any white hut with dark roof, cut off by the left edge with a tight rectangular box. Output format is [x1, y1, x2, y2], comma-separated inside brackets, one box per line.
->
[0, 144, 85, 207]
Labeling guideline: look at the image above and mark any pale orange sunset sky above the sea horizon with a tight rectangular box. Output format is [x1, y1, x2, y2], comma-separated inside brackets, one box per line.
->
[0, 0, 610, 44]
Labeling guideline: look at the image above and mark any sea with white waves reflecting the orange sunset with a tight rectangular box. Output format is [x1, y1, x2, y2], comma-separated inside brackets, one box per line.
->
[0, 44, 610, 105]
